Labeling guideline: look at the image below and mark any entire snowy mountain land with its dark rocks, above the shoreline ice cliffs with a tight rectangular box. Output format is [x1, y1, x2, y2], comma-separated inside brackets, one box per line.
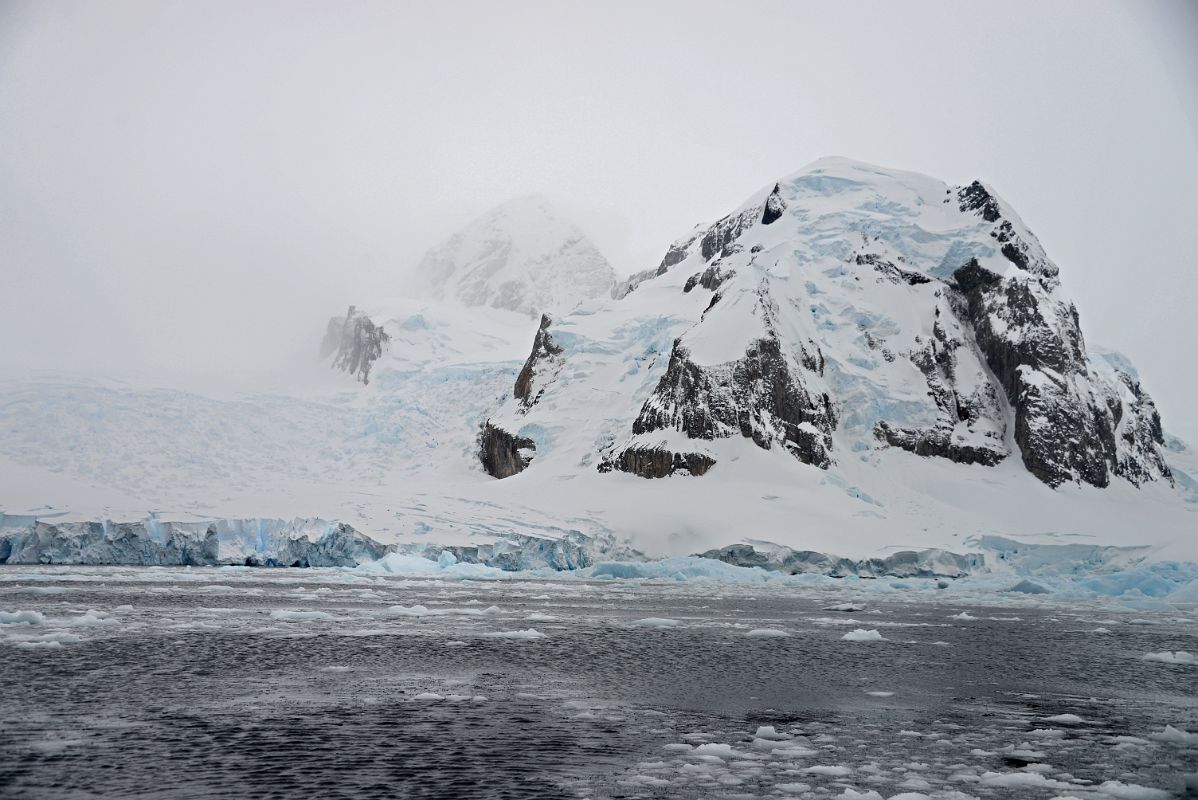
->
[0, 159, 1198, 560]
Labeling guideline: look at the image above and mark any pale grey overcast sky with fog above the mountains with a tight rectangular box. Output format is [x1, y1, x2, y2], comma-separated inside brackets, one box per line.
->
[0, 0, 1198, 438]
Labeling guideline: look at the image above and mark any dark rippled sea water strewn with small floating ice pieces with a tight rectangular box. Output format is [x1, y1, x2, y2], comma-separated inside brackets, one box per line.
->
[0, 566, 1198, 800]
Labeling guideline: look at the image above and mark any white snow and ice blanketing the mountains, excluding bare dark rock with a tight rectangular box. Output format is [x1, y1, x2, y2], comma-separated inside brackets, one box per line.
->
[0, 159, 1198, 567]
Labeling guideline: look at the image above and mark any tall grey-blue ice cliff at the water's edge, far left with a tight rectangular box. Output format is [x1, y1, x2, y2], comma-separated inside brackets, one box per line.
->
[0, 522, 389, 566]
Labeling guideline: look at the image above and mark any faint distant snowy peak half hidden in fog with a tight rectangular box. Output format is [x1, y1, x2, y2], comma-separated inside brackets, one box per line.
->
[418, 195, 616, 316]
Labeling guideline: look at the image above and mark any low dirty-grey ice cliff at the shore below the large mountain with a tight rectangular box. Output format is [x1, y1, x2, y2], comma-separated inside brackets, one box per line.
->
[698, 545, 986, 577]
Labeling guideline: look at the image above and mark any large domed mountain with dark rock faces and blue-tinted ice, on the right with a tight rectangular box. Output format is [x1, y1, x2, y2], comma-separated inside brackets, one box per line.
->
[486, 158, 1172, 486]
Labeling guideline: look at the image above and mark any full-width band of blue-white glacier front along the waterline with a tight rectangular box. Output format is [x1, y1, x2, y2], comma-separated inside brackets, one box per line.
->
[0, 516, 1198, 610]
